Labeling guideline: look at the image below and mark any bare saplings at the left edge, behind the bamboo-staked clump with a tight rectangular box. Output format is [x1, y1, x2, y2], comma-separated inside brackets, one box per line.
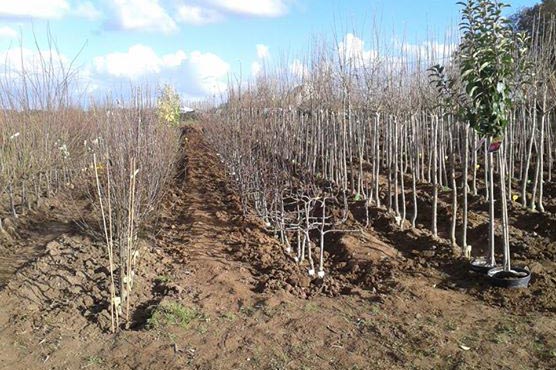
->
[0, 110, 86, 225]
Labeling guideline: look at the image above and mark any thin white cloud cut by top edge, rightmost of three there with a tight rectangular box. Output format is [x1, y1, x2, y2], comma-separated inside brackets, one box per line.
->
[210, 0, 288, 17]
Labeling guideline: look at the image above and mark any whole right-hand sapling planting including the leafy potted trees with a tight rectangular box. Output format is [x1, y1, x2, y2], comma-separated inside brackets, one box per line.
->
[205, 1, 556, 284]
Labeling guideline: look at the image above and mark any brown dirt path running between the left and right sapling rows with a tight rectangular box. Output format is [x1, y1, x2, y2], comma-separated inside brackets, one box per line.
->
[157, 127, 262, 309]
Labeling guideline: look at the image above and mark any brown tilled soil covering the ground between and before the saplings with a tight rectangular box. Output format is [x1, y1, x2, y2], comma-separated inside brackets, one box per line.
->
[0, 128, 556, 370]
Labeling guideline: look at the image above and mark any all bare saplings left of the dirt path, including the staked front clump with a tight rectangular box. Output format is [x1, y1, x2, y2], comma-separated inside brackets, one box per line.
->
[0, 87, 179, 330]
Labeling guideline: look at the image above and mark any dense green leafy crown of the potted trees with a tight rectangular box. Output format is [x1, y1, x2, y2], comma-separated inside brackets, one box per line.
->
[429, 0, 529, 137]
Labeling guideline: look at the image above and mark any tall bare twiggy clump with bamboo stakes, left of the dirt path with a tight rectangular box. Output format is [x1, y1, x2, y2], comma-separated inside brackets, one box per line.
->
[87, 92, 178, 331]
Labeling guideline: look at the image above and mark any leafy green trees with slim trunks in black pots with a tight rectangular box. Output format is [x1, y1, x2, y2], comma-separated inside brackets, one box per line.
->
[430, 0, 530, 286]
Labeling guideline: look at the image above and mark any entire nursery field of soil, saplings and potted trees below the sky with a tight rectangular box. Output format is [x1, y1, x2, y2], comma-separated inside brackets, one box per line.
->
[0, 0, 556, 370]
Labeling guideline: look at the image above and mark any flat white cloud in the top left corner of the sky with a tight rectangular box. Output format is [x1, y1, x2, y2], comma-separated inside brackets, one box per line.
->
[0, 0, 70, 19]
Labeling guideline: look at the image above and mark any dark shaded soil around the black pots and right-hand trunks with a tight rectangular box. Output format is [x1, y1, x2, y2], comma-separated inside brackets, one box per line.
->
[351, 168, 556, 314]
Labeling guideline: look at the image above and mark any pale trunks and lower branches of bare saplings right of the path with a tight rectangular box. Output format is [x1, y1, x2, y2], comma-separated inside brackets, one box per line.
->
[206, 92, 556, 277]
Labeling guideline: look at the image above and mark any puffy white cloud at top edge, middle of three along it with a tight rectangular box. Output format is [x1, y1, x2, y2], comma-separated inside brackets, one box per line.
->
[109, 0, 177, 33]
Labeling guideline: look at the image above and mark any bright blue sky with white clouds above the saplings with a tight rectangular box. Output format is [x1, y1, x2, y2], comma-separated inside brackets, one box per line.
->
[0, 0, 536, 99]
